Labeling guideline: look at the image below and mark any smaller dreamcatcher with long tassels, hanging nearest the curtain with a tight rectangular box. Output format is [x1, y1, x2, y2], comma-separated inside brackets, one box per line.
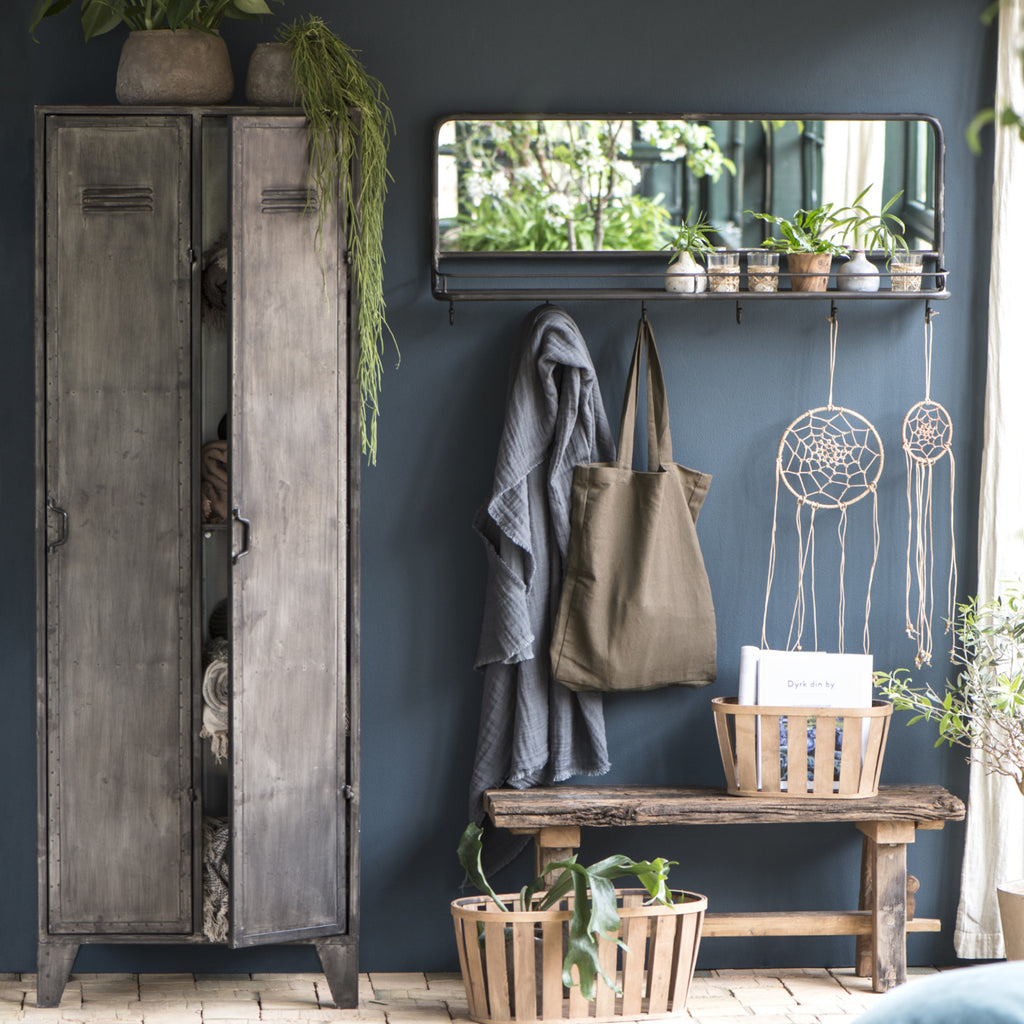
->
[903, 309, 956, 668]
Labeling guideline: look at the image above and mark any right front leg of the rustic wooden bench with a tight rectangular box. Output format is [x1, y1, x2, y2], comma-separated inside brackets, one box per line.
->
[857, 821, 914, 992]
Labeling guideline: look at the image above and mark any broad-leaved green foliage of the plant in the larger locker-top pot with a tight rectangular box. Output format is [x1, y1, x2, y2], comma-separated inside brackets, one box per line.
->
[29, 0, 280, 41]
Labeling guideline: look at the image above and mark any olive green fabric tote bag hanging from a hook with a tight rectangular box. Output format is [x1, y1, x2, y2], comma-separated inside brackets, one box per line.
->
[551, 313, 716, 691]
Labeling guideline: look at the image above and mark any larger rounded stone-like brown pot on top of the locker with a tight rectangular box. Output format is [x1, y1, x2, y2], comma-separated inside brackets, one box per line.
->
[117, 29, 234, 106]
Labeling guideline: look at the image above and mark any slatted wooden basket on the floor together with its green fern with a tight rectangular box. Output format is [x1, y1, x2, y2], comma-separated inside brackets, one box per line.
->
[452, 822, 708, 1024]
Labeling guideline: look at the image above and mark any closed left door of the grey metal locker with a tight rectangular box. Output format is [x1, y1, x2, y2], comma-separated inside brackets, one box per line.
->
[45, 115, 193, 933]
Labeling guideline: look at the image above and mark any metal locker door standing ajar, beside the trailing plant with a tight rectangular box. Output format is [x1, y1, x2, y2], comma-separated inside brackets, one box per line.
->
[230, 116, 348, 945]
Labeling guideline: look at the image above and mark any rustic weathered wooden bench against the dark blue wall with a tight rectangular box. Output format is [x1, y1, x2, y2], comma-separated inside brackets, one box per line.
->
[484, 785, 965, 992]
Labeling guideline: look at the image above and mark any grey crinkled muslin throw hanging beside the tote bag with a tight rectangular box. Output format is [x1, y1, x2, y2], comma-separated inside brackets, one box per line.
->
[469, 305, 614, 820]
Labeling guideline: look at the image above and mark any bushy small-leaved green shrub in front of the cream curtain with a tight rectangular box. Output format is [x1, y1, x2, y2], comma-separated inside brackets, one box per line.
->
[876, 590, 1024, 794]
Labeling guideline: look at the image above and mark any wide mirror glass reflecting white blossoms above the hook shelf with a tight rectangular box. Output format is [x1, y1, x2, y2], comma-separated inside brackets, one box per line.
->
[434, 115, 942, 254]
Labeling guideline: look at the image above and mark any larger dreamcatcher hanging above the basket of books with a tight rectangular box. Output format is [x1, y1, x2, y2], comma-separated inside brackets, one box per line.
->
[761, 310, 885, 654]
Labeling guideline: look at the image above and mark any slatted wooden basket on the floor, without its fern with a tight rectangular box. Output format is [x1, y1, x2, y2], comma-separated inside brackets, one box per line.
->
[452, 889, 708, 1024]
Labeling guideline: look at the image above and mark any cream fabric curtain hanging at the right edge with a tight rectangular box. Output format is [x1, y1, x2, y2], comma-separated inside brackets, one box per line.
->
[953, 0, 1024, 959]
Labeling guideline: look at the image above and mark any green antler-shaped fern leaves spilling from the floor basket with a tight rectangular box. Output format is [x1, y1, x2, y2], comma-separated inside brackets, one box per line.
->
[459, 821, 677, 1000]
